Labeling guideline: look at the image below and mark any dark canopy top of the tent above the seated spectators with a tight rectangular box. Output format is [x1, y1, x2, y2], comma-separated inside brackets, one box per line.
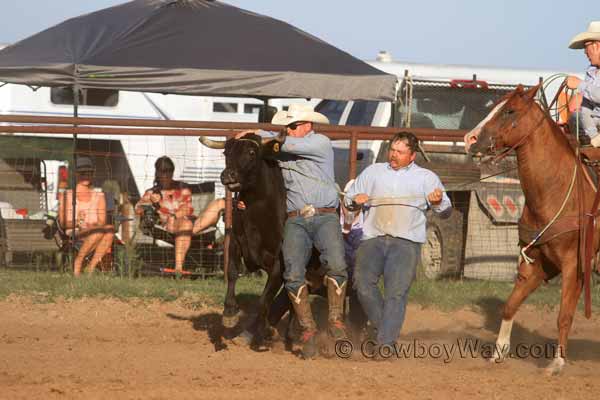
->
[0, 0, 396, 100]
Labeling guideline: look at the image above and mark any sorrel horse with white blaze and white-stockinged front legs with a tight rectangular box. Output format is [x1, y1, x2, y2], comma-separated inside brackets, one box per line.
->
[465, 86, 598, 375]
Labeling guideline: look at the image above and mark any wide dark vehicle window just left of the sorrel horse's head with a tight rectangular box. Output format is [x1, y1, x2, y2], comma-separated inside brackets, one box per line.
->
[397, 85, 508, 129]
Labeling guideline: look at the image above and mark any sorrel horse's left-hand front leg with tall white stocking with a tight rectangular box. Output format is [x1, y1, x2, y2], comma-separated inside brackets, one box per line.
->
[490, 254, 545, 362]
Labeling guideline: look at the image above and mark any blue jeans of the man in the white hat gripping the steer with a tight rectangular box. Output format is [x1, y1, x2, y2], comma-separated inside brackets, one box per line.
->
[283, 213, 348, 295]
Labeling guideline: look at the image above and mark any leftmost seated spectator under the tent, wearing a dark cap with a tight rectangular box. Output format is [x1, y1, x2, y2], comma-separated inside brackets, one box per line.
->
[58, 157, 114, 276]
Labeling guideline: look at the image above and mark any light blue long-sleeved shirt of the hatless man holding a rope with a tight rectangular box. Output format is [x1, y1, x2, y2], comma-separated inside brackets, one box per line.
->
[345, 162, 452, 243]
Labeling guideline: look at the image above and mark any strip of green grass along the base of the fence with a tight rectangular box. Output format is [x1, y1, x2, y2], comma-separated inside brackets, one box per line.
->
[0, 269, 600, 311]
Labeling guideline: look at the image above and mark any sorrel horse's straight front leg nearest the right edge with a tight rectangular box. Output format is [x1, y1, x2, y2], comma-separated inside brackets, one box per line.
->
[546, 255, 583, 375]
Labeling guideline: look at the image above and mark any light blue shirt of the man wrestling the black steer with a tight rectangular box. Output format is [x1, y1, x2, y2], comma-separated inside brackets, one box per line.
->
[259, 131, 339, 212]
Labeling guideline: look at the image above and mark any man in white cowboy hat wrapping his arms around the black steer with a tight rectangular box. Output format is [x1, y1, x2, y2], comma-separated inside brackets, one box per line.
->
[237, 104, 348, 358]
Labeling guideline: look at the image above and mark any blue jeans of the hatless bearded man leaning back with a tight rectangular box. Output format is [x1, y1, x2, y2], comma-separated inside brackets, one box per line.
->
[354, 236, 421, 344]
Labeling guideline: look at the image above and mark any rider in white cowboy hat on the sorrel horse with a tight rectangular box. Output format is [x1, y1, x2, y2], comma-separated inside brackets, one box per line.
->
[567, 21, 600, 147]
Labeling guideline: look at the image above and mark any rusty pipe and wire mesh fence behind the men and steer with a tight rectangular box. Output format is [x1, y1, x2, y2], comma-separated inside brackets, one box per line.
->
[0, 116, 518, 279]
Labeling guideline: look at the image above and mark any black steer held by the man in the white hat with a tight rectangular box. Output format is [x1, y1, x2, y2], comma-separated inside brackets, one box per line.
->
[221, 134, 287, 341]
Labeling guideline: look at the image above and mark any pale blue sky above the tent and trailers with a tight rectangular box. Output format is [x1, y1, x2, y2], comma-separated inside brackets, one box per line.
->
[0, 0, 600, 72]
